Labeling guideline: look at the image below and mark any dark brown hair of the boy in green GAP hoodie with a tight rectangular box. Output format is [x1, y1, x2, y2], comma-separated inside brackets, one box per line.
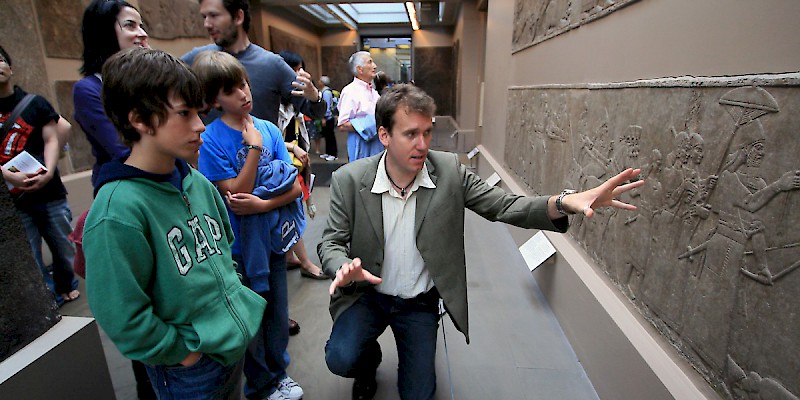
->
[103, 47, 203, 145]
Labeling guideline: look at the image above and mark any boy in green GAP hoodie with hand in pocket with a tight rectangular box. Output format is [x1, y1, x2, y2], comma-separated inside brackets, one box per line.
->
[83, 48, 266, 400]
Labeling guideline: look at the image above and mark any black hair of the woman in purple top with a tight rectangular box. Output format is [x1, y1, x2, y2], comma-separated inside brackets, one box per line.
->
[80, 0, 139, 76]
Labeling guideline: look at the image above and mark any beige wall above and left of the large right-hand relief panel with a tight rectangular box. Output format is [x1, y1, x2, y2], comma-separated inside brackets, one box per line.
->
[482, 0, 800, 162]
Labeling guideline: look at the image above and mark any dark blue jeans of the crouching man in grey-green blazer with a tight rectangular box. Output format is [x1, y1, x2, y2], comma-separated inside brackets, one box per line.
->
[325, 288, 439, 400]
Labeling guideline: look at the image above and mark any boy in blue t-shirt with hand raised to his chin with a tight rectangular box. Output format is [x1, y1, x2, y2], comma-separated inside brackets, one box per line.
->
[192, 51, 305, 400]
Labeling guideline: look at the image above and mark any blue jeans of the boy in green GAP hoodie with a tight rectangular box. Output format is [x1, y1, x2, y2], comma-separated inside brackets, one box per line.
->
[145, 354, 242, 400]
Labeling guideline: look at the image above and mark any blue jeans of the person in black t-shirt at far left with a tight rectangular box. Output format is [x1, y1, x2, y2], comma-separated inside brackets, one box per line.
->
[16, 200, 78, 304]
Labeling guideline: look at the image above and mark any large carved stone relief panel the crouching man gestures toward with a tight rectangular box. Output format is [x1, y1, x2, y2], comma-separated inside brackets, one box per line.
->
[505, 73, 800, 399]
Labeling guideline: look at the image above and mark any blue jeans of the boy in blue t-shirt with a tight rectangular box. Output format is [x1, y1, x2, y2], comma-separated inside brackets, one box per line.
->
[233, 253, 289, 400]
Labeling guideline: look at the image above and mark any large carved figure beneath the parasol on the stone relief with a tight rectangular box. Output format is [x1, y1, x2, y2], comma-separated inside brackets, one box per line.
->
[684, 120, 800, 367]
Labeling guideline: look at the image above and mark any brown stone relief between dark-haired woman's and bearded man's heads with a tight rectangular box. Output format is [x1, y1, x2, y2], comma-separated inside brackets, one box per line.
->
[138, 0, 208, 39]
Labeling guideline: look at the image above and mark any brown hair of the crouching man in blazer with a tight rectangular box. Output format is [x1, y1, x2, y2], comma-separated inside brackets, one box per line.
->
[375, 84, 436, 134]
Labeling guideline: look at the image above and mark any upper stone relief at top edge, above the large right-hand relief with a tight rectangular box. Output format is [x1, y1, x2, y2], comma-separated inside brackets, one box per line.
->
[511, 0, 638, 52]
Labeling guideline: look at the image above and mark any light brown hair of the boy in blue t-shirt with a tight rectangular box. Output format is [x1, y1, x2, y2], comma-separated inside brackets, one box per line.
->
[192, 50, 250, 106]
